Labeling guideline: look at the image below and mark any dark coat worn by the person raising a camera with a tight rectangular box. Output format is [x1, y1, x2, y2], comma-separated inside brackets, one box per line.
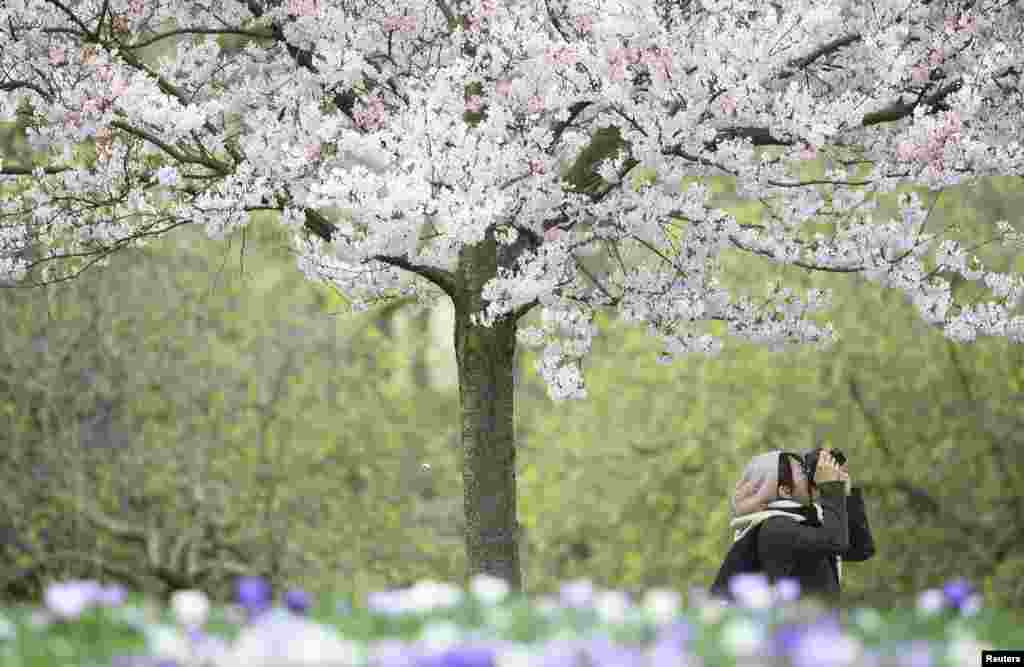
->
[711, 482, 874, 600]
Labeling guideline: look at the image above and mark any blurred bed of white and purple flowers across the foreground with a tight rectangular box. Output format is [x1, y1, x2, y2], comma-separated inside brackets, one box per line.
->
[0, 575, 1024, 667]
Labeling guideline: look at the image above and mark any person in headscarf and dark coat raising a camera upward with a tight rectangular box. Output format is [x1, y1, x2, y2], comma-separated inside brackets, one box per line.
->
[712, 450, 874, 599]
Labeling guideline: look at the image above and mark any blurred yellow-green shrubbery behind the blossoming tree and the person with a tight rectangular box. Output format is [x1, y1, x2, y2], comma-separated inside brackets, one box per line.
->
[0, 15, 1024, 609]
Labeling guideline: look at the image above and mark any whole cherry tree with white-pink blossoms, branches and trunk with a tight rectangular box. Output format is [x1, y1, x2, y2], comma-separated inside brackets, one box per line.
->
[0, 0, 1024, 588]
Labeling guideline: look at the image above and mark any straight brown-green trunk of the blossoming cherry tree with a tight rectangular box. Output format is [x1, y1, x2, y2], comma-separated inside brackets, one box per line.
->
[455, 228, 522, 591]
